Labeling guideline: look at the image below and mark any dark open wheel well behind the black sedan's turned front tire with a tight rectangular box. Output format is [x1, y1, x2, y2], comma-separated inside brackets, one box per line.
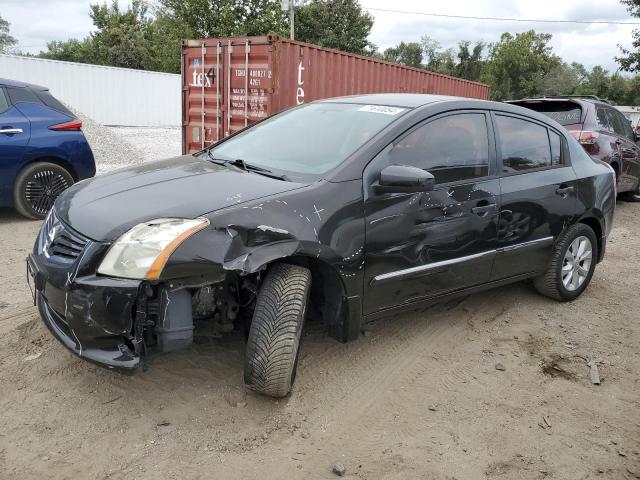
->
[270, 256, 350, 341]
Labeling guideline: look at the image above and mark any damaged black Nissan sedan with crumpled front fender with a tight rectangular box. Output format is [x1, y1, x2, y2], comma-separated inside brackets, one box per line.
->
[27, 94, 615, 396]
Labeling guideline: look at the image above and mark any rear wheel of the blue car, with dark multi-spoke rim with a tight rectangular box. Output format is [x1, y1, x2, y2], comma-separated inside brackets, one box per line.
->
[13, 162, 73, 220]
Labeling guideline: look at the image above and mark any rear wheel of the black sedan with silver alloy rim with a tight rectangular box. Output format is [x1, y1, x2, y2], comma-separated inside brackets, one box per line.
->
[533, 223, 598, 302]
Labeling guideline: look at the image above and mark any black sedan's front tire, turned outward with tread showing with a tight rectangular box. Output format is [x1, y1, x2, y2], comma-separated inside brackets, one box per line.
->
[244, 263, 311, 398]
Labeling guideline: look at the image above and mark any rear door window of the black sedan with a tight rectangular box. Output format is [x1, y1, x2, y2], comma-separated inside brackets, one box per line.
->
[496, 115, 559, 173]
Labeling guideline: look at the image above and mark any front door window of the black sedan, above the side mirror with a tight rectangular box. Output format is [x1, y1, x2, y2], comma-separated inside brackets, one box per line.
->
[388, 113, 489, 183]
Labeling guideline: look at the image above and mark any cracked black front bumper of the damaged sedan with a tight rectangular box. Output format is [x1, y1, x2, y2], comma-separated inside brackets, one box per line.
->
[27, 255, 144, 371]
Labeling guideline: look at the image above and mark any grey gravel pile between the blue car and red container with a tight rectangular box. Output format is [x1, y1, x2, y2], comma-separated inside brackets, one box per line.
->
[74, 111, 148, 174]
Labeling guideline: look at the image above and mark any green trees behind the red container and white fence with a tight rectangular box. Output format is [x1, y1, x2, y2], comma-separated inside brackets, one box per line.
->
[28, 0, 640, 105]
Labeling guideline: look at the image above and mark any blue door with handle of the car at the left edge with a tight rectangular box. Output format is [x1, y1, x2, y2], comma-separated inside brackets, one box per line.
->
[0, 87, 31, 205]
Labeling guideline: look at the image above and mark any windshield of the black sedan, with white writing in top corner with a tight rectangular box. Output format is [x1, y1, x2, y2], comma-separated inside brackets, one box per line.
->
[210, 103, 408, 179]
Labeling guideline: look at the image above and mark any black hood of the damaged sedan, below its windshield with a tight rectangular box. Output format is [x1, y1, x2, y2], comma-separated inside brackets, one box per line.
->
[55, 155, 306, 242]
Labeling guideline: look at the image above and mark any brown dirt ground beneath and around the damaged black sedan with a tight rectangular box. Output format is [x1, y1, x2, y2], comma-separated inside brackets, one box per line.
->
[0, 203, 640, 480]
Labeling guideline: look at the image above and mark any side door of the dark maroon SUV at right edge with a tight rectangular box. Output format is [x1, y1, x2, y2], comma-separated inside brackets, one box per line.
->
[606, 107, 640, 190]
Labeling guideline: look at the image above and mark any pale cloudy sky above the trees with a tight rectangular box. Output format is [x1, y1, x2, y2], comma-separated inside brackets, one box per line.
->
[0, 0, 640, 71]
